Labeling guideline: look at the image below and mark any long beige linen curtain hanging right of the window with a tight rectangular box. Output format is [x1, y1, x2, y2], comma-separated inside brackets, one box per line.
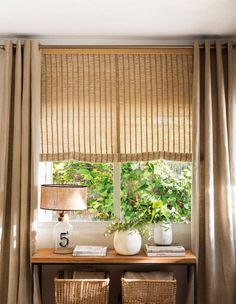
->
[192, 41, 236, 304]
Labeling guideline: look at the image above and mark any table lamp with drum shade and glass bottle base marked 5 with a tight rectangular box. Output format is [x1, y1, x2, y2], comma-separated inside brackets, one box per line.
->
[40, 185, 87, 253]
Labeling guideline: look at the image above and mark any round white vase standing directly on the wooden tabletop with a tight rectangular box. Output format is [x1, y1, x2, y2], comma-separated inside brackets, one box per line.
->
[114, 229, 142, 255]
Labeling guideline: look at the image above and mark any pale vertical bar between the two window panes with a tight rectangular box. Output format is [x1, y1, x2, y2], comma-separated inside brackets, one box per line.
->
[113, 163, 121, 218]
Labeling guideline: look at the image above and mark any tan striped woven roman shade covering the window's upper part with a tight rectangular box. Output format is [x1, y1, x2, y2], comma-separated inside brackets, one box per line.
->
[41, 48, 193, 162]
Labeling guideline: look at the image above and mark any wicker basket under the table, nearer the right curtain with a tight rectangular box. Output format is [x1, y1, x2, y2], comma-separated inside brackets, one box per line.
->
[122, 277, 176, 304]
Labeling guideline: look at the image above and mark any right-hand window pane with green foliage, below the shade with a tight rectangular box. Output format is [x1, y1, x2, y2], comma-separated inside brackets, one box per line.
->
[121, 160, 191, 222]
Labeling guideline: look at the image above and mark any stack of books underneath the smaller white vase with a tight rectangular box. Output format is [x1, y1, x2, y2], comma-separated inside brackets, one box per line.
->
[144, 244, 185, 257]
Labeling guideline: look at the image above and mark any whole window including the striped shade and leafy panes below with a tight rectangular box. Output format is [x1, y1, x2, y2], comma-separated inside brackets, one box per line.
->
[40, 48, 193, 222]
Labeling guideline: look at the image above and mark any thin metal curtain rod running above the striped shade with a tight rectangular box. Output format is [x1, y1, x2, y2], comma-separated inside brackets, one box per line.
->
[0, 43, 232, 50]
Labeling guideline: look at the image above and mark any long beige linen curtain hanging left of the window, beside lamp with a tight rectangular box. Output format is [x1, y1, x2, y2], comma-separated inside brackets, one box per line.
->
[0, 41, 40, 304]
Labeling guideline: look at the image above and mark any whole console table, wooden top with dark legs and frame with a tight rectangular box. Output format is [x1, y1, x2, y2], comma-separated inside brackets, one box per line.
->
[31, 248, 197, 303]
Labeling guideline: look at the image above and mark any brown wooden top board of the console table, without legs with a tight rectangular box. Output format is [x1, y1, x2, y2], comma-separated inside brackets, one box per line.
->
[31, 248, 197, 264]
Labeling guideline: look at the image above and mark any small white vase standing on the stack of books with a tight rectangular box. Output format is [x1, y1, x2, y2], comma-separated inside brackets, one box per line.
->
[154, 223, 173, 245]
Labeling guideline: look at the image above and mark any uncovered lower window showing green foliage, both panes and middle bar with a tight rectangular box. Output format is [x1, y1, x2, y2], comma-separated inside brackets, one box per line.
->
[39, 160, 191, 222]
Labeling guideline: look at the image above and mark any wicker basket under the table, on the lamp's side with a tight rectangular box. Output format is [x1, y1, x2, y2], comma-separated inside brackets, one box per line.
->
[54, 278, 110, 304]
